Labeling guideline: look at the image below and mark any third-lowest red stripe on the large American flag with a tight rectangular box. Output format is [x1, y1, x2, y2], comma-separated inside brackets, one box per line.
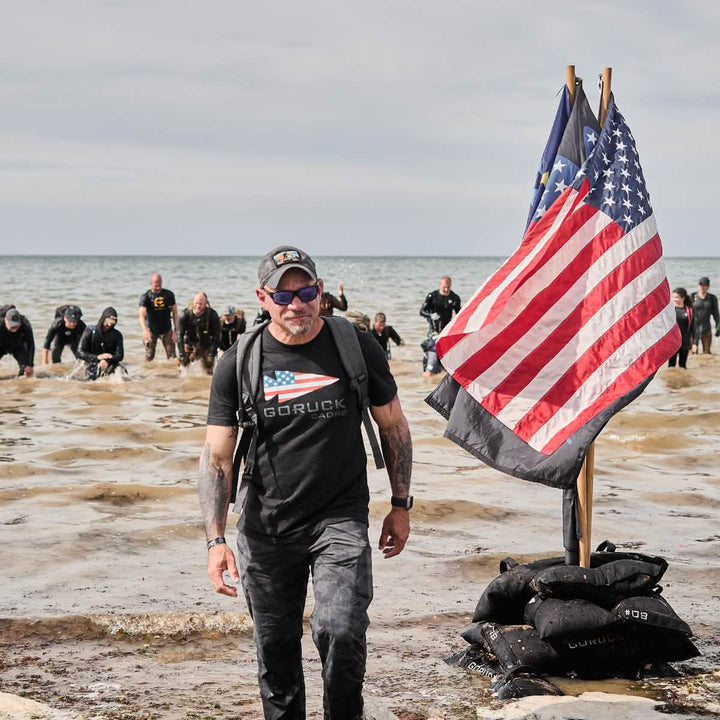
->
[482, 233, 662, 415]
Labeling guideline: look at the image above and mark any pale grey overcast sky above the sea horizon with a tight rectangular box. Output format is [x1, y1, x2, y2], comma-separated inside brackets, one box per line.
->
[0, 0, 720, 262]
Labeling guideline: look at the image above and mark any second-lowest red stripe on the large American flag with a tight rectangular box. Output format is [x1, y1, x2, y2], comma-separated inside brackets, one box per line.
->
[513, 272, 670, 442]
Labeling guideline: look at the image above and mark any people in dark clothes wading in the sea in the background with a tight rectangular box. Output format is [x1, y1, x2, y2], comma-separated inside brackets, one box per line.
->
[0, 273, 720, 380]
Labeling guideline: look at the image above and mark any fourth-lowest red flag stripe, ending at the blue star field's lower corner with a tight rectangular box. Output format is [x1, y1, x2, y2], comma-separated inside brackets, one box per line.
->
[453, 205, 624, 387]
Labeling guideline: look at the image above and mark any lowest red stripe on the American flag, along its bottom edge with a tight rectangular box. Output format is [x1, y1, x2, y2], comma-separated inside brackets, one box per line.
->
[542, 324, 682, 455]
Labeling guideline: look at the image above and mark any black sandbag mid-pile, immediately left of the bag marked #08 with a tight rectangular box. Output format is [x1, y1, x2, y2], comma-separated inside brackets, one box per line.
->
[525, 595, 618, 640]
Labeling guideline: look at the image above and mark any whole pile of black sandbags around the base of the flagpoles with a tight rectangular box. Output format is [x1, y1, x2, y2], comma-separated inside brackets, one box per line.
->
[447, 545, 700, 698]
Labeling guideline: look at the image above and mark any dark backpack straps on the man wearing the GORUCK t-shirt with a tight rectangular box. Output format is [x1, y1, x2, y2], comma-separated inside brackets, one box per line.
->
[230, 317, 385, 510]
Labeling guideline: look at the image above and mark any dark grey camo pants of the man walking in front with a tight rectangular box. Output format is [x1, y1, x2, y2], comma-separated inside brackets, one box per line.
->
[238, 520, 372, 720]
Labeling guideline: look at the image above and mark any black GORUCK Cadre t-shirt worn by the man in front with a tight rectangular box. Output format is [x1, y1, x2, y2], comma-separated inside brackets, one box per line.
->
[207, 326, 397, 536]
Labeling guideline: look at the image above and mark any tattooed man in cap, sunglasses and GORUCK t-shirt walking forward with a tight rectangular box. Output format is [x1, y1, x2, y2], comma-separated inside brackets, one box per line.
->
[198, 246, 412, 719]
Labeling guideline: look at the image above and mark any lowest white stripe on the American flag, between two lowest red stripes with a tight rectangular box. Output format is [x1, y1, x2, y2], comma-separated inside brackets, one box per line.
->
[528, 312, 677, 451]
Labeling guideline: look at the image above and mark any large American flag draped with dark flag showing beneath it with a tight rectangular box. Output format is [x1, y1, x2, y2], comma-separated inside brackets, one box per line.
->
[428, 87, 680, 487]
